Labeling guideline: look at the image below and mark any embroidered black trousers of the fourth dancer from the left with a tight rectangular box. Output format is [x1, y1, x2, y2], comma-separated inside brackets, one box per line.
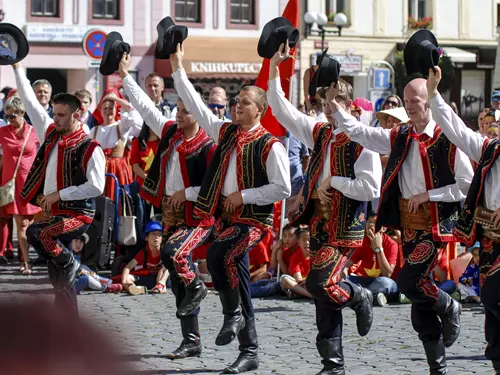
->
[306, 217, 355, 342]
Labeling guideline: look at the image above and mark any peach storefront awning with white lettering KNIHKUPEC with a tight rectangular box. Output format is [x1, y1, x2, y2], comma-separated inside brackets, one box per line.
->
[155, 37, 262, 79]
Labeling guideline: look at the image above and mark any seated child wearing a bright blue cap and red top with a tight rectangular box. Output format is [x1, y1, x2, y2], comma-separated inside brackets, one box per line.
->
[121, 221, 169, 295]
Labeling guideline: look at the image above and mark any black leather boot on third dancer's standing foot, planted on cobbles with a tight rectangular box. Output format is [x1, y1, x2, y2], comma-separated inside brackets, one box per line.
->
[222, 318, 259, 374]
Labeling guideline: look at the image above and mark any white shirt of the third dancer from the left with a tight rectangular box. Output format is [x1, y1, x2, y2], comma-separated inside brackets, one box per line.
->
[172, 69, 292, 206]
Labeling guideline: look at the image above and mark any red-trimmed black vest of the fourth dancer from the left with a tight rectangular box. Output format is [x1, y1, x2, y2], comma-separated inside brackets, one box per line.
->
[292, 123, 367, 247]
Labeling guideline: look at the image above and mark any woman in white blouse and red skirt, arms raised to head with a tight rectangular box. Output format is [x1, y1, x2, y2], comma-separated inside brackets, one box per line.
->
[89, 89, 144, 199]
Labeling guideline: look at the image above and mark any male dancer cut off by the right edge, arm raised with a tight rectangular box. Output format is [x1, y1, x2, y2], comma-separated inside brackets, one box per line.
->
[427, 66, 500, 374]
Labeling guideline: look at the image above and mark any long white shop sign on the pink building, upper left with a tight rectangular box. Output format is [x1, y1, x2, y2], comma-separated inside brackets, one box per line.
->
[26, 25, 88, 43]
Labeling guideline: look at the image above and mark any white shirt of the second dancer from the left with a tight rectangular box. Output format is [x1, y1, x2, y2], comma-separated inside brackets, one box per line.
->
[122, 75, 200, 202]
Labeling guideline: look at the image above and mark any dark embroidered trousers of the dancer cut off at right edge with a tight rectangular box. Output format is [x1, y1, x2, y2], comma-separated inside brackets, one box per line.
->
[479, 237, 500, 364]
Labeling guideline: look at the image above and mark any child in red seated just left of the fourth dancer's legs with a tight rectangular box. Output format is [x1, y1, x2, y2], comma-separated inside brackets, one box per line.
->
[280, 228, 313, 299]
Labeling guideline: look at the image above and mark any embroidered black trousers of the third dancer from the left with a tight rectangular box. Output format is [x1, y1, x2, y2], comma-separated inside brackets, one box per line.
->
[207, 222, 265, 319]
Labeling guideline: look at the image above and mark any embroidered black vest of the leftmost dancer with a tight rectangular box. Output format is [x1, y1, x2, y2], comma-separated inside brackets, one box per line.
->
[20, 125, 100, 224]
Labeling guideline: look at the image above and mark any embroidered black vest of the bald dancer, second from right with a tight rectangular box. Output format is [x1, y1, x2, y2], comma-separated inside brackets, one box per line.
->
[377, 125, 460, 242]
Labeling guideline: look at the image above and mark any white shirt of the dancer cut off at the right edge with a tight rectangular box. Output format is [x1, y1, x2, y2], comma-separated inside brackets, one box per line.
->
[429, 95, 500, 210]
